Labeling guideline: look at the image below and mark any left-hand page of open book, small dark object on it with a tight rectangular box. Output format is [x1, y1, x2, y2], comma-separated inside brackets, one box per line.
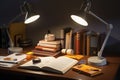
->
[20, 57, 55, 70]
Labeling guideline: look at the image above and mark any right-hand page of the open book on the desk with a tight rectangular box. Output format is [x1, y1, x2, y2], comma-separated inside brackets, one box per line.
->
[44, 56, 78, 74]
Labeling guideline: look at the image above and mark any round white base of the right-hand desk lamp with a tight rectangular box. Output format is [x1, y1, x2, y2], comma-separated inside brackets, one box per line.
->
[88, 56, 107, 66]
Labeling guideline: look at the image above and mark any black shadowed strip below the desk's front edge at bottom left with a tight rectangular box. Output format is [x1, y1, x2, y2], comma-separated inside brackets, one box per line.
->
[0, 72, 73, 80]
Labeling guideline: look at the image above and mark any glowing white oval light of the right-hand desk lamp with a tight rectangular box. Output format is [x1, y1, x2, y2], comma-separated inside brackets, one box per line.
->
[71, 15, 88, 26]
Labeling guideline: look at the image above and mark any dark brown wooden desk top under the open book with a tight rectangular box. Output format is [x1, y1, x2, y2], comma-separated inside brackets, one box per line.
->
[0, 47, 120, 80]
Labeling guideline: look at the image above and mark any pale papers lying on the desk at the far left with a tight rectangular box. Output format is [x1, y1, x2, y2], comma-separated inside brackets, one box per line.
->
[0, 53, 26, 63]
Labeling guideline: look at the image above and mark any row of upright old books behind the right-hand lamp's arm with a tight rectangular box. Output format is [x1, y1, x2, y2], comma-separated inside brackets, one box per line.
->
[61, 28, 105, 56]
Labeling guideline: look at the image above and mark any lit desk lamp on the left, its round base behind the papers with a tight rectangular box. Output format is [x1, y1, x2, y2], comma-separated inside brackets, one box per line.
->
[7, 1, 40, 52]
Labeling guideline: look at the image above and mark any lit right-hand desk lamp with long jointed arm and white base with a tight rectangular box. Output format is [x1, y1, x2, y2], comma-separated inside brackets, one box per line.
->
[71, 0, 113, 66]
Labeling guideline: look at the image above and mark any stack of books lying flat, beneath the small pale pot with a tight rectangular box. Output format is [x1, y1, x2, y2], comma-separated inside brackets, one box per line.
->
[33, 40, 61, 56]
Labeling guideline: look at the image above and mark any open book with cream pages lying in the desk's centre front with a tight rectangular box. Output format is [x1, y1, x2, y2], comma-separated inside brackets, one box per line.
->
[19, 56, 78, 74]
